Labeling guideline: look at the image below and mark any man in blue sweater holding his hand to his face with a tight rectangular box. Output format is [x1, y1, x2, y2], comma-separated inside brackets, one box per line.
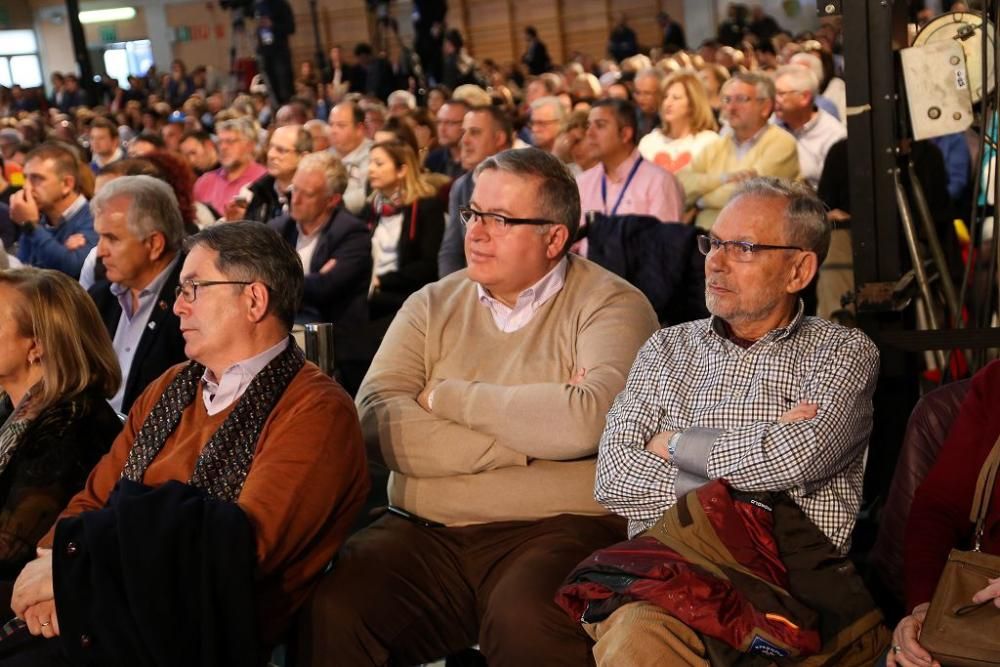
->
[10, 143, 97, 278]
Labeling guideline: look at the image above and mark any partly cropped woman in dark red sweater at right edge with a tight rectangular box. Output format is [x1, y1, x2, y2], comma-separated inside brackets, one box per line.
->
[887, 361, 1000, 667]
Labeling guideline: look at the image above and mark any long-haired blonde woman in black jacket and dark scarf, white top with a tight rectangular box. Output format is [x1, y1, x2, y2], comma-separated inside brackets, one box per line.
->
[362, 141, 445, 328]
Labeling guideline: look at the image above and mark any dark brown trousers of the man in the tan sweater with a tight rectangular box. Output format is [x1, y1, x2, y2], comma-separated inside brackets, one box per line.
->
[299, 514, 625, 667]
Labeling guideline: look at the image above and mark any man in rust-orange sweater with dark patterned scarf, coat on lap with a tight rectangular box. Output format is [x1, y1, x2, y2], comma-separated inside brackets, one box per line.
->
[8, 222, 368, 665]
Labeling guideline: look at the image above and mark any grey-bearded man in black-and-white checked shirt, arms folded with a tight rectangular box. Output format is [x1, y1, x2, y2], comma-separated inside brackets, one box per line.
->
[586, 179, 878, 665]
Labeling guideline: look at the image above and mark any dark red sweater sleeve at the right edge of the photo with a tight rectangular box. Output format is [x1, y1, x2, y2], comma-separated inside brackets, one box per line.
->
[904, 361, 1000, 609]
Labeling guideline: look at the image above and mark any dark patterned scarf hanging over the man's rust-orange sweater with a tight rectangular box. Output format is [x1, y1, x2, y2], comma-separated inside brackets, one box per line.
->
[122, 341, 305, 502]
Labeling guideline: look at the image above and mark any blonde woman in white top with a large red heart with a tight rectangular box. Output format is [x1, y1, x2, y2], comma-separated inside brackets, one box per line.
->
[639, 70, 719, 174]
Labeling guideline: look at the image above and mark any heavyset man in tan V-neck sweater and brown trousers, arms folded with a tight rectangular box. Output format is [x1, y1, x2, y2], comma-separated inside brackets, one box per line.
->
[301, 148, 657, 667]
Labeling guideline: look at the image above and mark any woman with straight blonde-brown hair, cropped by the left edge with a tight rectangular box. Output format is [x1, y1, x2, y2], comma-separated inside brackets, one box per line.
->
[0, 268, 122, 608]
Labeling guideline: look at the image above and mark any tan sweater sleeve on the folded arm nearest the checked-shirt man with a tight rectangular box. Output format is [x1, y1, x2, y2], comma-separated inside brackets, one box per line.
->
[434, 289, 658, 461]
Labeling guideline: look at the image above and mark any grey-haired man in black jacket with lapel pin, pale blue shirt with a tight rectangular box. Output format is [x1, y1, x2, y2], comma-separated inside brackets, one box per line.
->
[88, 176, 185, 414]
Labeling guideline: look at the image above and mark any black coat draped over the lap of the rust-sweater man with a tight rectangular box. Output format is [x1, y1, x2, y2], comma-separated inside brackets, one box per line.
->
[53, 480, 266, 667]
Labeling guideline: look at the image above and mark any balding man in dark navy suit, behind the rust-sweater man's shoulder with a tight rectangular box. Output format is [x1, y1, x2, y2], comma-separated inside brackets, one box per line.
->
[268, 153, 372, 395]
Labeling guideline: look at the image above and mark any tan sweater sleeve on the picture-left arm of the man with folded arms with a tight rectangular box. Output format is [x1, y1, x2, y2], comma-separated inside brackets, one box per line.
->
[357, 292, 527, 477]
